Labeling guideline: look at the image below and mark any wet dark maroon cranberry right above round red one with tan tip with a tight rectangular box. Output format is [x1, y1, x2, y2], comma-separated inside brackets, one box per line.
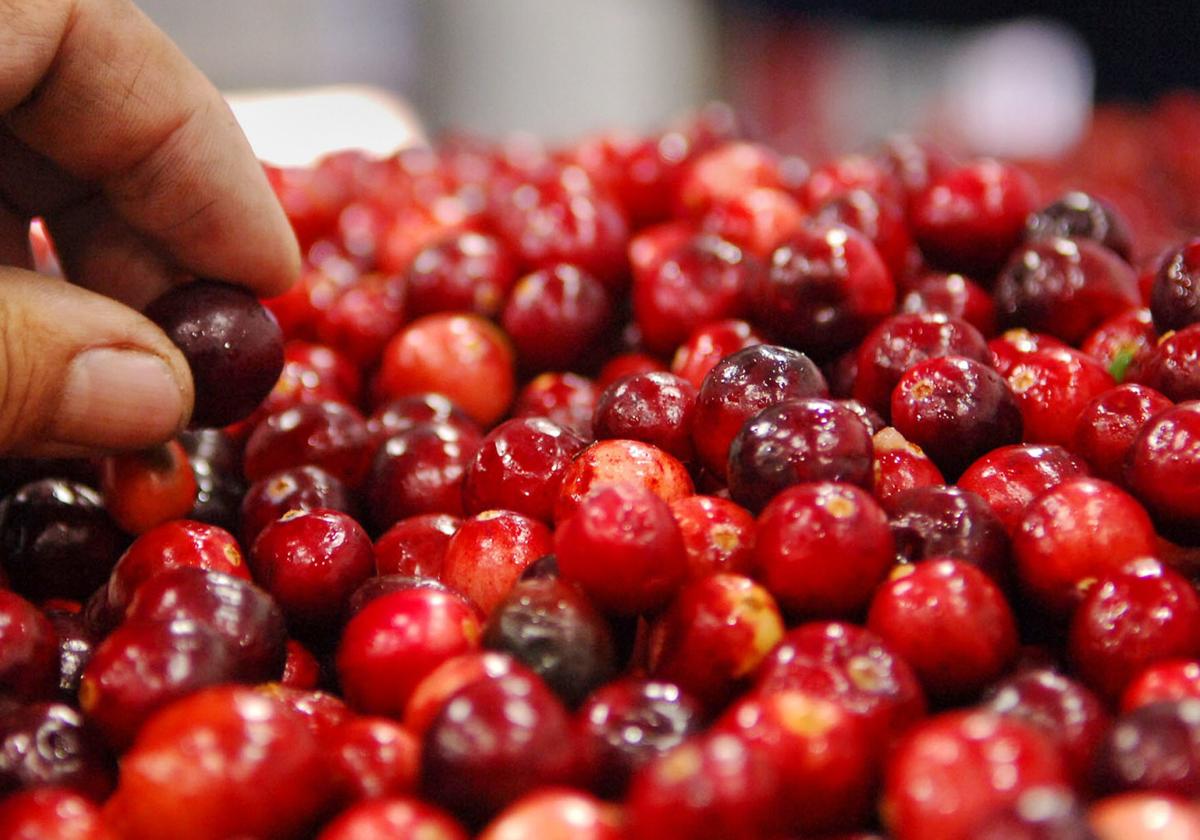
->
[728, 397, 874, 511]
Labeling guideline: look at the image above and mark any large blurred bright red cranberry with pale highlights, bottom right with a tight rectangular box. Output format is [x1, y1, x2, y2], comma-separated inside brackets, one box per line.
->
[881, 712, 1068, 840]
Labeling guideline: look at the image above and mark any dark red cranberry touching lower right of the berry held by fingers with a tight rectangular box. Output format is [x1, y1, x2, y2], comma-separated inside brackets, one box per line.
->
[242, 401, 372, 487]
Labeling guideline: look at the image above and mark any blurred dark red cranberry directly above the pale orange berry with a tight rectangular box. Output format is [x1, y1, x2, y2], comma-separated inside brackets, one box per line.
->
[404, 232, 517, 318]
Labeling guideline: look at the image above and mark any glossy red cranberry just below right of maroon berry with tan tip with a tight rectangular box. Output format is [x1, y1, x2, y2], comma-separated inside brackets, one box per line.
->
[958, 444, 1087, 534]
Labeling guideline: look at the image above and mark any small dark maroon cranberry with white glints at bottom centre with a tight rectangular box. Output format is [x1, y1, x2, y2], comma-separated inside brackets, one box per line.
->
[577, 677, 703, 798]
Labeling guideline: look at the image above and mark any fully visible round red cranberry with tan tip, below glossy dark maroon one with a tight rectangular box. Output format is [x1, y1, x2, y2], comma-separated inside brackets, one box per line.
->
[755, 482, 895, 617]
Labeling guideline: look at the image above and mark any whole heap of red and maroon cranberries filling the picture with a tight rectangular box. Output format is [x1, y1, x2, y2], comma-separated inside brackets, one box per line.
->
[7, 100, 1200, 840]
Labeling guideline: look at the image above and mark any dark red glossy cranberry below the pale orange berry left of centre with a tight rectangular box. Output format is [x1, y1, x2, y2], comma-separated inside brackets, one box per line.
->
[367, 422, 480, 530]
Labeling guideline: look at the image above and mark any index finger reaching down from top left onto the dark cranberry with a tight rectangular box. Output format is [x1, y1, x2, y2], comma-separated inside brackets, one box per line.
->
[0, 0, 300, 296]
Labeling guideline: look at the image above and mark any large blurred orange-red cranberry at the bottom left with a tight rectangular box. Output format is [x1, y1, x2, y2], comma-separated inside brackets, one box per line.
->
[104, 686, 326, 840]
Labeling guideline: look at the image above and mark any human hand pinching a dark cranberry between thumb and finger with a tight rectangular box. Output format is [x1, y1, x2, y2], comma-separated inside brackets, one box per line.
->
[0, 0, 300, 456]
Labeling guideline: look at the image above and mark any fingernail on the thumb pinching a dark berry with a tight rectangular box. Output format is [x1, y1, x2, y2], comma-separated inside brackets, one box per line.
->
[50, 347, 185, 449]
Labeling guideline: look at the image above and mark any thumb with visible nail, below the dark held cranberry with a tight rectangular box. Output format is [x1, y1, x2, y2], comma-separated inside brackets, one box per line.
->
[0, 268, 192, 456]
